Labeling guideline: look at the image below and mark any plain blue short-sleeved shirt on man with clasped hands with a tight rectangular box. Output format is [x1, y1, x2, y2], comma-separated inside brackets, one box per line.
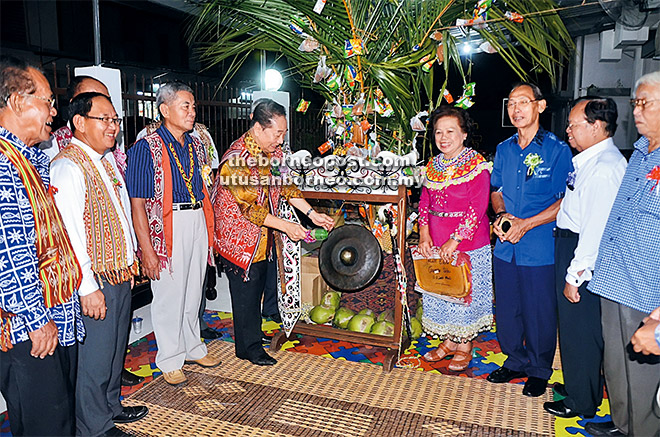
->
[490, 128, 573, 266]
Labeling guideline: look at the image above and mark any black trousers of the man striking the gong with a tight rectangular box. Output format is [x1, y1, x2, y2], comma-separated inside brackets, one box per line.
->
[224, 260, 273, 360]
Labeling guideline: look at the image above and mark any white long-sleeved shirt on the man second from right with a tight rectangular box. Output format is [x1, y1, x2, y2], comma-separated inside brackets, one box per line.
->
[557, 138, 627, 287]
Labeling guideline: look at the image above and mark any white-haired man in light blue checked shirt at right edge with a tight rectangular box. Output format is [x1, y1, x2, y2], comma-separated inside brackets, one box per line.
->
[585, 71, 660, 436]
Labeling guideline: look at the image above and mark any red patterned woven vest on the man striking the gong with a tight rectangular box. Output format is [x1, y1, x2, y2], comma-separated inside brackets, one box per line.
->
[212, 134, 282, 277]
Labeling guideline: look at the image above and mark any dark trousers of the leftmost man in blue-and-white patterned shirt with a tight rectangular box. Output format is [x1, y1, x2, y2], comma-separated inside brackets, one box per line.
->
[0, 340, 78, 436]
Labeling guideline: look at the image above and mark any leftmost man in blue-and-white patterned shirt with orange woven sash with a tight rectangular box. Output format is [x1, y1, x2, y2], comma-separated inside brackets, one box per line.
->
[0, 56, 85, 436]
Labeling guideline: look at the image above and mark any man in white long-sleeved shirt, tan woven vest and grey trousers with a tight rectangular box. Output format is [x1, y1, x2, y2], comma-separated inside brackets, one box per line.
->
[51, 93, 148, 436]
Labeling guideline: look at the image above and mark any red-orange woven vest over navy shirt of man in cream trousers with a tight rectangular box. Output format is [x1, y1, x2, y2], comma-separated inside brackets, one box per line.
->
[138, 132, 213, 271]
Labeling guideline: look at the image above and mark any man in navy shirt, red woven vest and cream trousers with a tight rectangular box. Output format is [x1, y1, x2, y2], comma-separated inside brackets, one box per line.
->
[126, 82, 220, 385]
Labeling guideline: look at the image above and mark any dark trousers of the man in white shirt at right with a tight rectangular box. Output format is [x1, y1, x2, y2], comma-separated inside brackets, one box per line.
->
[555, 229, 604, 416]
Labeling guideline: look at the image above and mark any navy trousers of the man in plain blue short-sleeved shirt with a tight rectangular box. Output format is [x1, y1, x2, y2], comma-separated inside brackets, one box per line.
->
[493, 257, 557, 379]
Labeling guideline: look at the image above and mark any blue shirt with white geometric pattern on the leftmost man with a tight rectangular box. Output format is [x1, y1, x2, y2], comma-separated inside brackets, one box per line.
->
[0, 126, 85, 346]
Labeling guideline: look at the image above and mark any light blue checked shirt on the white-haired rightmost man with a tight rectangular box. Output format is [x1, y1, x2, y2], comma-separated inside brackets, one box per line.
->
[587, 137, 660, 313]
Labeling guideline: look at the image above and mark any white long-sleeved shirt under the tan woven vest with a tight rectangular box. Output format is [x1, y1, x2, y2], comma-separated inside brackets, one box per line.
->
[50, 138, 137, 296]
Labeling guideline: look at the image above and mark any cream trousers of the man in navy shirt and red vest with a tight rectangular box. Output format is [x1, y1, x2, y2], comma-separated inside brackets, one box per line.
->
[151, 208, 208, 373]
